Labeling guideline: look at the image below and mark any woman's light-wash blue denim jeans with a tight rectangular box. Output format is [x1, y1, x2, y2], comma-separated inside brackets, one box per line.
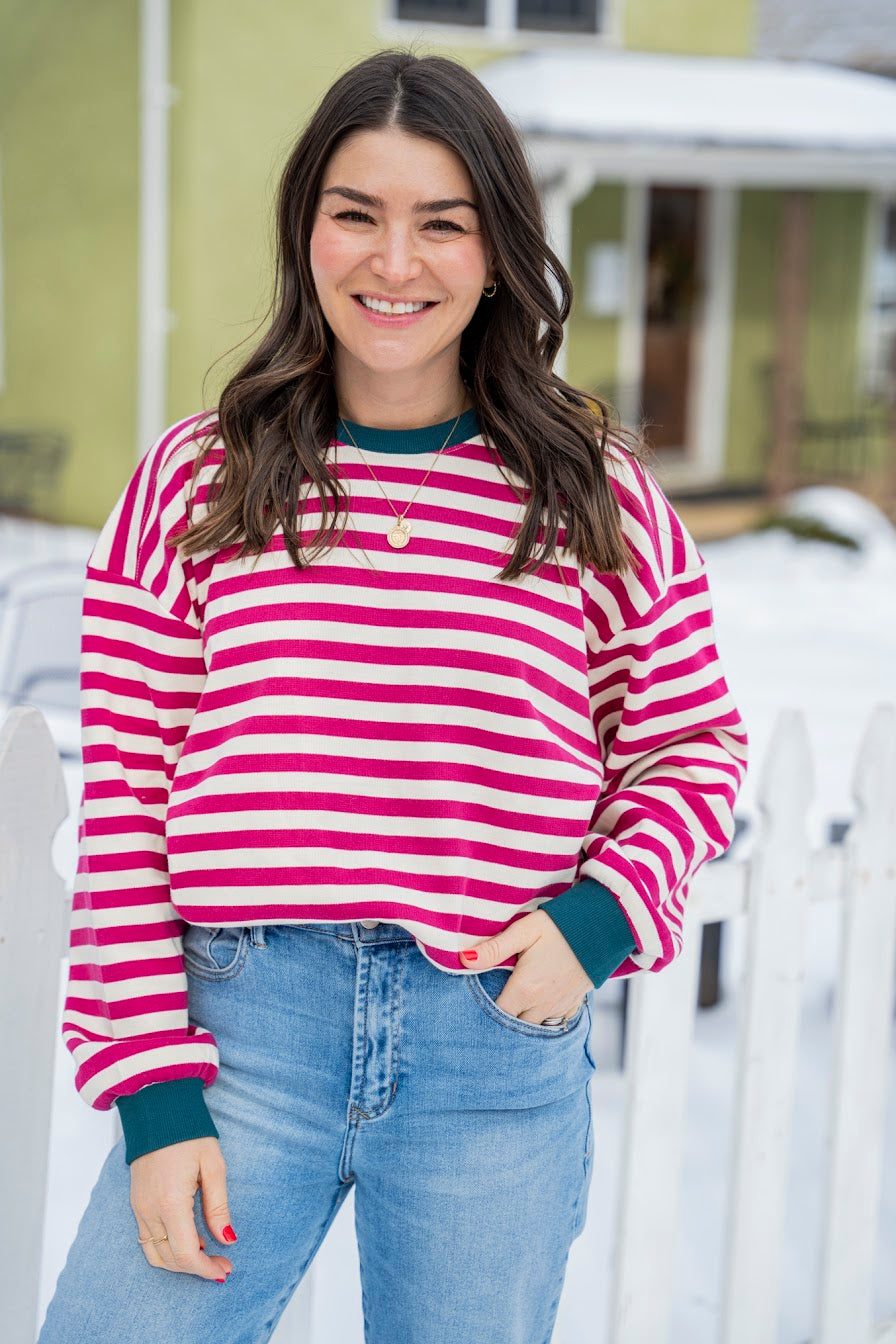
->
[39, 921, 595, 1344]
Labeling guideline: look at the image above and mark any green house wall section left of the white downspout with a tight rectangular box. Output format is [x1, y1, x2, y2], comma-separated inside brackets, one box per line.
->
[0, 0, 138, 524]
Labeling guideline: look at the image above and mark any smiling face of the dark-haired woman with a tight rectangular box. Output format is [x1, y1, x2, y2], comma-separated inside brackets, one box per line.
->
[310, 128, 493, 391]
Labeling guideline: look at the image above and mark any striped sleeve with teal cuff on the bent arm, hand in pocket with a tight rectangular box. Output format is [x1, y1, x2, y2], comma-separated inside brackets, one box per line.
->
[543, 456, 748, 985]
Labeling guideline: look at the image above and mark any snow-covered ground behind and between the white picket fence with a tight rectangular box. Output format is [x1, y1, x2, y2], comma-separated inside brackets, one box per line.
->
[10, 488, 896, 1344]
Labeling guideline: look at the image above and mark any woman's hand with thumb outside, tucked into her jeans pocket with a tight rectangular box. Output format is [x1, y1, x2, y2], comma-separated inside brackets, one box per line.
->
[461, 910, 594, 1023]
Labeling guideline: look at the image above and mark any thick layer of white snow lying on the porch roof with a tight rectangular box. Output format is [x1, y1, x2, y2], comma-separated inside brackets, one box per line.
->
[476, 46, 896, 159]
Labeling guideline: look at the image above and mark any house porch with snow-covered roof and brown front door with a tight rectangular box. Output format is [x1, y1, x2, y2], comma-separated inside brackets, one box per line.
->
[477, 48, 896, 512]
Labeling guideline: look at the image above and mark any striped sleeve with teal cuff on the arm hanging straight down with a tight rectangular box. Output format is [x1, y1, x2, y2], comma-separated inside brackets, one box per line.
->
[62, 413, 218, 1163]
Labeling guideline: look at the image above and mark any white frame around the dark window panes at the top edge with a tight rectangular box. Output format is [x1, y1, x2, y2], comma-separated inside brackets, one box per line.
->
[377, 0, 625, 50]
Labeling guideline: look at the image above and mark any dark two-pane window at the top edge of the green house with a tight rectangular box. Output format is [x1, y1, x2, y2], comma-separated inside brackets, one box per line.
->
[387, 0, 607, 38]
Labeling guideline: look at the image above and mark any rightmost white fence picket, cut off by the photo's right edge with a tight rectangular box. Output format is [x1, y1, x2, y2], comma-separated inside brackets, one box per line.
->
[815, 704, 896, 1344]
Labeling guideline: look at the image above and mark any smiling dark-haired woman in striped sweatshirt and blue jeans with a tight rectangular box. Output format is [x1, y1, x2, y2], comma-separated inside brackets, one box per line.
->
[40, 51, 747, 1344]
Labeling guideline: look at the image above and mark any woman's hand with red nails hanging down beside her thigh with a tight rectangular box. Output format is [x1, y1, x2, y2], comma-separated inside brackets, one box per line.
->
[130, 1136, 235, 1279]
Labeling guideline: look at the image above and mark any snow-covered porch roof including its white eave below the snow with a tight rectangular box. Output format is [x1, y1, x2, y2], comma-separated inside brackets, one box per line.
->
[476, 47, 896, 187]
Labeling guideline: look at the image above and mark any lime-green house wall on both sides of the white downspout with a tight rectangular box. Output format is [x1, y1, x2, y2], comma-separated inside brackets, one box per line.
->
[0, 0, 501, 526]
